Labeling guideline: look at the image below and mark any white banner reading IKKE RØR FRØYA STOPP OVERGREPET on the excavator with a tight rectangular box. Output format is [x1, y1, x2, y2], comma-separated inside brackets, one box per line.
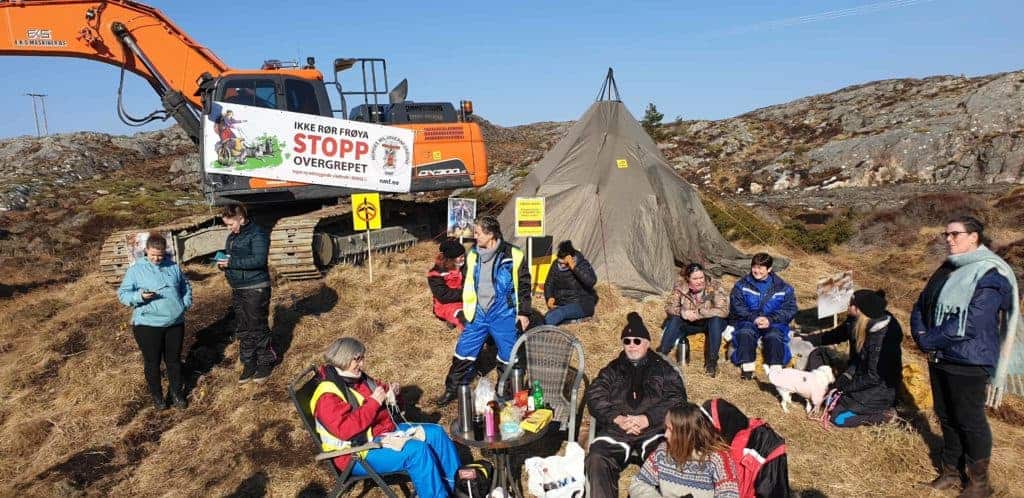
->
[204, 102, 414, 192]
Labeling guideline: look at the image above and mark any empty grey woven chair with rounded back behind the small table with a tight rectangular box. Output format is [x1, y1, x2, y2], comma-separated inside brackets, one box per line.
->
[498, 325, 586, 442]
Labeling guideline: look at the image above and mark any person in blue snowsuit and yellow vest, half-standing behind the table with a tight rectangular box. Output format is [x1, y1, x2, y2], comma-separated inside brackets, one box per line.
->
[434, 216, 530, 406]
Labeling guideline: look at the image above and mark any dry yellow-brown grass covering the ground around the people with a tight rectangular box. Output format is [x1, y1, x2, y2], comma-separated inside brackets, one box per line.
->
[0, 234, 1024, 497]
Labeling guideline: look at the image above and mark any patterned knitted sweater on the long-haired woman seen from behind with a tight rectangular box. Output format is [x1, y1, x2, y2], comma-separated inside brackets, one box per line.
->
[630, 443, 739, 498]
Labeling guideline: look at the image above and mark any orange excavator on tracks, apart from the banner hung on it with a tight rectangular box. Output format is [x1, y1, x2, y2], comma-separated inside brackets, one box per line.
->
[0, 0, 487, 282]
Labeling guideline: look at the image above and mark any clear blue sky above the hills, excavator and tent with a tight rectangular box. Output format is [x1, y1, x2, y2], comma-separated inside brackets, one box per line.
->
[0, 0, 1024, 137]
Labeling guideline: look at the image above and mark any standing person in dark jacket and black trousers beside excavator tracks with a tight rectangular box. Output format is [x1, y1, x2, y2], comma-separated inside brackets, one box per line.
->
[217, 204, 276, 384]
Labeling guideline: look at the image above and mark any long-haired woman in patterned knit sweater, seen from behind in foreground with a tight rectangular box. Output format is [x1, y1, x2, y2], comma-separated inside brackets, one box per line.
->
[630, 403, 739, 498]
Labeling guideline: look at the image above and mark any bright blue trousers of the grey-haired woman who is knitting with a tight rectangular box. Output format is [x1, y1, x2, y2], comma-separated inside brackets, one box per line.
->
[352, 423, 460, 496]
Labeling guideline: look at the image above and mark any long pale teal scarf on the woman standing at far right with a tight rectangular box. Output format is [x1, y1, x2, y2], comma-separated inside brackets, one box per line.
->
[934, 246, 1024, 407]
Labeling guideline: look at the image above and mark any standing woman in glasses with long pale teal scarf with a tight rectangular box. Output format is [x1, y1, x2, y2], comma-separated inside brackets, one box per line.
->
[910, 216, 1020, 498]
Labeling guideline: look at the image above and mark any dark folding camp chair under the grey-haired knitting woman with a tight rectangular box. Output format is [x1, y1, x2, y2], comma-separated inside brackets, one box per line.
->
[288, 365, 410, 498]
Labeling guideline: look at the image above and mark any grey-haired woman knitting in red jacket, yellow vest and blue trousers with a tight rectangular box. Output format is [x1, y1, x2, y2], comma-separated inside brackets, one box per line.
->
[309, 337, 461, 496]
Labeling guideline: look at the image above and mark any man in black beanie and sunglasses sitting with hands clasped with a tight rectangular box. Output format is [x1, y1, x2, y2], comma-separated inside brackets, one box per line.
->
[584, 313, 686, 498]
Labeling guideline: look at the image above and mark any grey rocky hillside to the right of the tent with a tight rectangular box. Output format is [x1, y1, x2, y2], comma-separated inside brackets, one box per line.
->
[662, 72, 1024, 194]
